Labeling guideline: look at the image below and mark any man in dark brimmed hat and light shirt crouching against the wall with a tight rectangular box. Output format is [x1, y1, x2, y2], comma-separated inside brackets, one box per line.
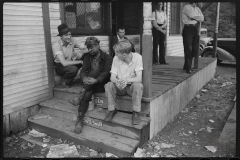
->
[52, 23, 86, 88]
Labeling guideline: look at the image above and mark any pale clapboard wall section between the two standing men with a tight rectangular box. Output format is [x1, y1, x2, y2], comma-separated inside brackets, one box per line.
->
[166, 2, 184, 56]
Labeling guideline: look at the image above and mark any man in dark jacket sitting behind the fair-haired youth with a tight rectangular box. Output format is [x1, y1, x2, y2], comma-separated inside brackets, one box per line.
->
[110, 27, 135, 57]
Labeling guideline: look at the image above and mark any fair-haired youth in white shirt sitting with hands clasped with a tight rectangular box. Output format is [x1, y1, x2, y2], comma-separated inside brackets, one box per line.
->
[105, 40, 143, 125]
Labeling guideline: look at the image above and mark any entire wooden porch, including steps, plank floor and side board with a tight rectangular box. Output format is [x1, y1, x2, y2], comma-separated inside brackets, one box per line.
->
[28, 57, 216, 157]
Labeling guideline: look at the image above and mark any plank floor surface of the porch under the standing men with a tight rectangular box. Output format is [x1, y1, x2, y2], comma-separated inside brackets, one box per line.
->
[150, 56, 214, 100]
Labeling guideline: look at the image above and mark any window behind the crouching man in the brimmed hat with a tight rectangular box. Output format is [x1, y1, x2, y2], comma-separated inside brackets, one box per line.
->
[63, 2, 110, 35]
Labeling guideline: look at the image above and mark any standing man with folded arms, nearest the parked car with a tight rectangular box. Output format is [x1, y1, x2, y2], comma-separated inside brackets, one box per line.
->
[182, 2, 204, 74]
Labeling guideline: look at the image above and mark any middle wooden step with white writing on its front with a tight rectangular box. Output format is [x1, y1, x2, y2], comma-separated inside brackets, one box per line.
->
[39, 98, 150, 145]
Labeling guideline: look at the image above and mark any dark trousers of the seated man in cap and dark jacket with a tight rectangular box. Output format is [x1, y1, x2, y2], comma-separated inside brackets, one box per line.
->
[78, 71, 105, 115]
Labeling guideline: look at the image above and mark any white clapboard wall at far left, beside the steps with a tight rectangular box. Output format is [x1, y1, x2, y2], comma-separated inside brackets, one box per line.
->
[3, 3, 49, 115]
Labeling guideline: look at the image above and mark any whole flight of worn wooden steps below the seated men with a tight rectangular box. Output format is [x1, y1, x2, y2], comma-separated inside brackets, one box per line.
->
[28, 82, 150, 157]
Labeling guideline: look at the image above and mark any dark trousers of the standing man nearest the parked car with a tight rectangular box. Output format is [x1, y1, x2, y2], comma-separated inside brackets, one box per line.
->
[182, 26, 198, 70]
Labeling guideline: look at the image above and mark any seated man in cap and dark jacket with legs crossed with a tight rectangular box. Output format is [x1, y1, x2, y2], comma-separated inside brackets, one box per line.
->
[68, 37, 112, 134]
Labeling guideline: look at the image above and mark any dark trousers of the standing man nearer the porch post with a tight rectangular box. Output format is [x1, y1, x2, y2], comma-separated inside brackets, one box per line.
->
[152, 24, 166, 64]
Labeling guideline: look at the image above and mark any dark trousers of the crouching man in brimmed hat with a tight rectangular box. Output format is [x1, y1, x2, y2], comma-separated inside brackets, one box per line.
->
[55, 63, 82, 85]
